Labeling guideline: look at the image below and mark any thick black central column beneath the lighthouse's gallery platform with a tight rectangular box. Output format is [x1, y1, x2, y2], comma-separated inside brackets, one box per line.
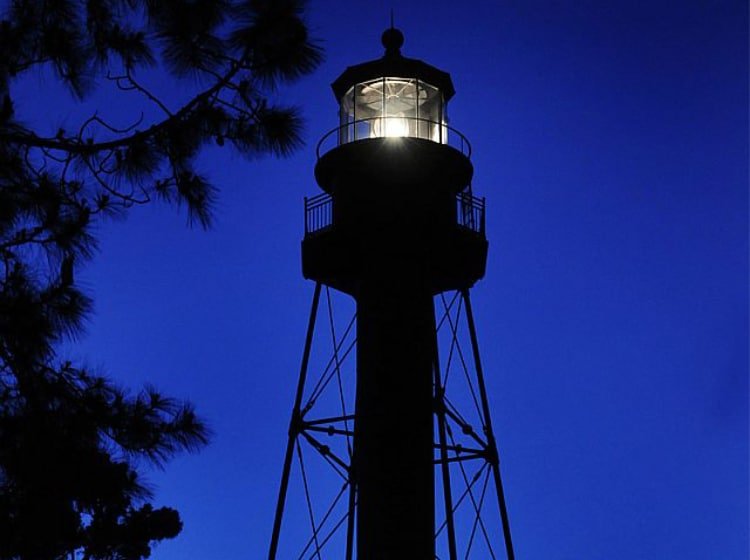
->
[354, 273, 435, 560]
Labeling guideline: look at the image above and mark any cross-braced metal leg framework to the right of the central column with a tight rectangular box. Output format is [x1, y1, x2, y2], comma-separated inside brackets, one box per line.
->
[434, 290, 515, 560]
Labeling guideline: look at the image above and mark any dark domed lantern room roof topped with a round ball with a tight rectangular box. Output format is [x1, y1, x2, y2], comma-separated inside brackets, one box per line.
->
[331, 27, 456, 101]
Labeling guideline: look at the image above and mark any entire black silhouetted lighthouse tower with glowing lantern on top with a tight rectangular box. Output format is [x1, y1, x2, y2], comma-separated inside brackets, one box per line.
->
[269, 28, 513, 560]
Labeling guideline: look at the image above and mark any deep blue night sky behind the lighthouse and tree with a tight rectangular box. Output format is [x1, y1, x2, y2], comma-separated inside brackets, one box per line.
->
[18, 0, 748, 560]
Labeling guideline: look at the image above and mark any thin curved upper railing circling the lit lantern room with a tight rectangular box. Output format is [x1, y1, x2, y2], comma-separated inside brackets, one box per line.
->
[316, 117, 471, 159]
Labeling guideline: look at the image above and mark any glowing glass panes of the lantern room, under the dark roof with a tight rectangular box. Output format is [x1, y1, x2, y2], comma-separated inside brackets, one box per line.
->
[339, 77, 445, 143]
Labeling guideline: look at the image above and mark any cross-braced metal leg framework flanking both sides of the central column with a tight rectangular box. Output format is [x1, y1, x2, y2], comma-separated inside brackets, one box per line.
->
[268, 283, 514, 560]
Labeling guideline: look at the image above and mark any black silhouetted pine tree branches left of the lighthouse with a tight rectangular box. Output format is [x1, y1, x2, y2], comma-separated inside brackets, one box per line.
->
[0, 0, 321, 559]
